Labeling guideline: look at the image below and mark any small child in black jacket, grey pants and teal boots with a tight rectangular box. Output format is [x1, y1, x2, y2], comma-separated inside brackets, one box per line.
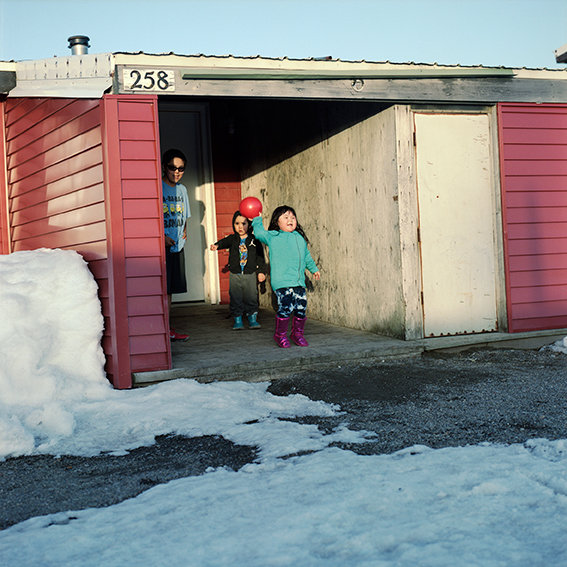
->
[211, 211, 266, 331]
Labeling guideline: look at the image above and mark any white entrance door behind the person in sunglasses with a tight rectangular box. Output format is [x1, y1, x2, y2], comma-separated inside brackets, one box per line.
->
[159, 100, 220, 303]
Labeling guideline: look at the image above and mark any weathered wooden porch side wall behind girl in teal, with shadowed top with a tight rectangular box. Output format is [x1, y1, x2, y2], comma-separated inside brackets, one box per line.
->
[237, 103, 415, 337]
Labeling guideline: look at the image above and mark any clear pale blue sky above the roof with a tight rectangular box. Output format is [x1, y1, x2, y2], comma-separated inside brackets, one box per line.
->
[0, 0, 567, 69]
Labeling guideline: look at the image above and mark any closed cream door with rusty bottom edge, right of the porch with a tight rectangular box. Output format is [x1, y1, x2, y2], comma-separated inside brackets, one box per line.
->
[414, 113, 497, 337]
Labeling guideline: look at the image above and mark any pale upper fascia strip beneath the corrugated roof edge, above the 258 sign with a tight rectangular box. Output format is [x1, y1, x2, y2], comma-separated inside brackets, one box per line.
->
[7, 51, 567, 98]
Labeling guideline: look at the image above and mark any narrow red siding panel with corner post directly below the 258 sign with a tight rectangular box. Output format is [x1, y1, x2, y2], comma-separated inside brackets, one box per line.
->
[103, 95, 171, 387]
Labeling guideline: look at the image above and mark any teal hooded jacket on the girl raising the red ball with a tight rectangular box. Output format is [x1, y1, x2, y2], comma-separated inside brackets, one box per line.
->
[252, 217, 319, 289]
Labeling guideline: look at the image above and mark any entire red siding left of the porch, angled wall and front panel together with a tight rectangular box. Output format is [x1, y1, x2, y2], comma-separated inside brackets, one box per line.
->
[0, 96, 171, 388]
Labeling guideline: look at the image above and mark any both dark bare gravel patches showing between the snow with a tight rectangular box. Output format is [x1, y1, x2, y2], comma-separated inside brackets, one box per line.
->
[0, 349, 567, 529]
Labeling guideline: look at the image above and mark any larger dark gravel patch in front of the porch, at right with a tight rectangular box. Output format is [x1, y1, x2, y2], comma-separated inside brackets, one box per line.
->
[270, 349, 567, 454]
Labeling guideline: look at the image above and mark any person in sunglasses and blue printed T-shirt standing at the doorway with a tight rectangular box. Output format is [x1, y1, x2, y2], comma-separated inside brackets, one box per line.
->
[161, 149, 191, 340]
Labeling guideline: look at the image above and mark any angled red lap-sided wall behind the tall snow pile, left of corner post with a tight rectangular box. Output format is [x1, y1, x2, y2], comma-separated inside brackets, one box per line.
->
[1, 98, 114, 381]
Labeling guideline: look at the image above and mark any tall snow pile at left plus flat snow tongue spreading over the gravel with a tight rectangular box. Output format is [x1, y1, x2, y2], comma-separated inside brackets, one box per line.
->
[0, 249, 364, 459]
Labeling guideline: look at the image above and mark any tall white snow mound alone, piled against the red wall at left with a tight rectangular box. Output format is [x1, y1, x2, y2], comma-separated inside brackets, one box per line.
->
[0, 249, 110, 457]
